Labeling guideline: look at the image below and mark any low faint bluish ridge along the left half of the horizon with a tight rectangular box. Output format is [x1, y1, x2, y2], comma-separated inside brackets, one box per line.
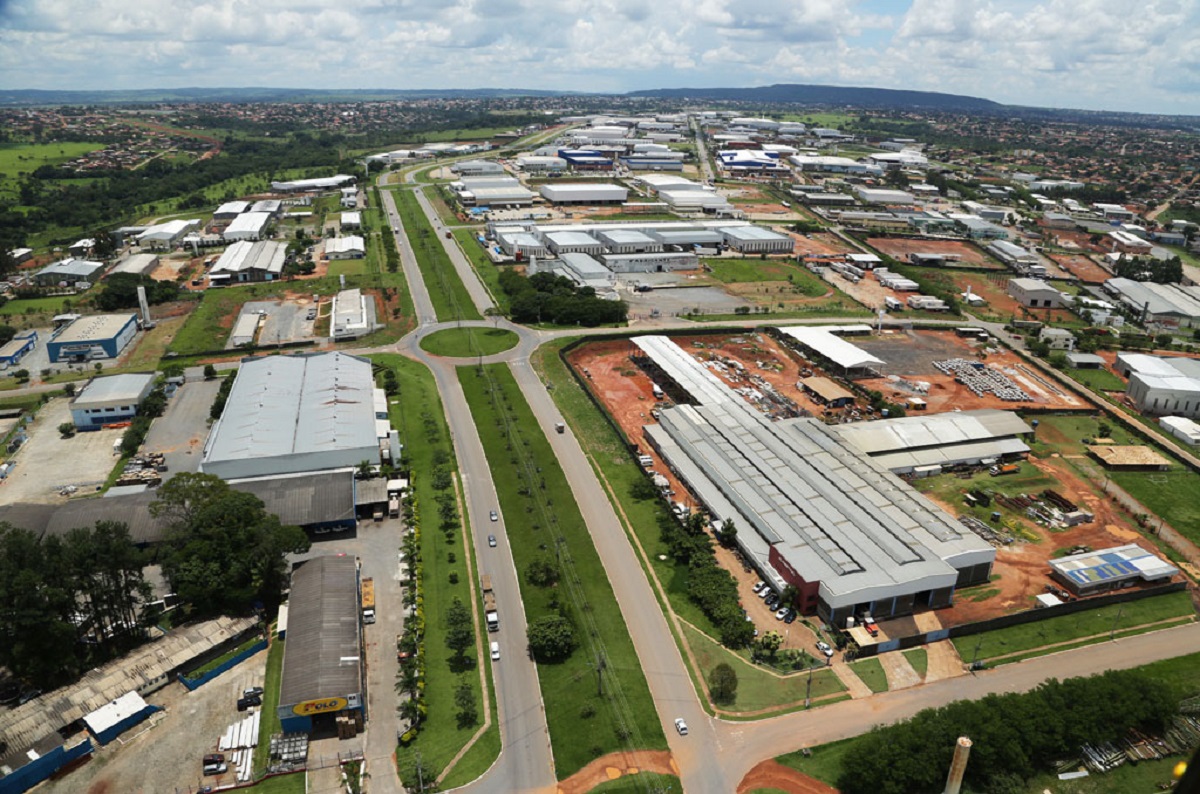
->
[0, 88, 566, 107]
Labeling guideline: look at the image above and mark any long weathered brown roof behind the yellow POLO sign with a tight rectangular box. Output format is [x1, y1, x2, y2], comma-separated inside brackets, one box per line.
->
[280, 557, 362, 708]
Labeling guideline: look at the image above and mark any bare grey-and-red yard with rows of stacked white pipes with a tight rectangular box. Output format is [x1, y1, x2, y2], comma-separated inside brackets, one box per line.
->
[854, 331, 1091, 413]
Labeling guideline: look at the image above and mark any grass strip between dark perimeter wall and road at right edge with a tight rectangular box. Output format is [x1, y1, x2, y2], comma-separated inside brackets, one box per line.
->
[952, 593, 1195, 663]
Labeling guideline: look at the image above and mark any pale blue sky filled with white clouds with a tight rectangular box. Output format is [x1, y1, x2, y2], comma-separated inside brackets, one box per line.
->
[0, 0, 1200, 114]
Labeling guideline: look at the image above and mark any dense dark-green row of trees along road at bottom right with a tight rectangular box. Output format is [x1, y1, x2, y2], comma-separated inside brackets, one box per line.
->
[838, 670, 1177, 794]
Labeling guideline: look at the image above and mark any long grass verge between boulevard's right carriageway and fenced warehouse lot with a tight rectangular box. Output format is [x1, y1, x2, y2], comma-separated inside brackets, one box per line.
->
[533, 337, 718, 634]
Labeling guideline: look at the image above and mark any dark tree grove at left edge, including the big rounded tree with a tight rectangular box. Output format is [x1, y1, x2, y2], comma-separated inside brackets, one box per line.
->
[0, 474, 308, 690]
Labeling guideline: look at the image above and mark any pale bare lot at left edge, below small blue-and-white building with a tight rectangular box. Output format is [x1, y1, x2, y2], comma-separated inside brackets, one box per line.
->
[0, 397, 125, 505]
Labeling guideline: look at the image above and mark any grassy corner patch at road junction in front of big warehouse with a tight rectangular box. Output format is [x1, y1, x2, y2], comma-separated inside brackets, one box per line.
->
[683, 625, 844, 716]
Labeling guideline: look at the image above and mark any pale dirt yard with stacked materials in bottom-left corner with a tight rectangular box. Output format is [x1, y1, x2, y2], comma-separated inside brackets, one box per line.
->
[38, 651, 266, 794]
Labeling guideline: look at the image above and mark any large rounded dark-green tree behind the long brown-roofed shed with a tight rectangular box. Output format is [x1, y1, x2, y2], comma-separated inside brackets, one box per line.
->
[150, 473, 310, 615]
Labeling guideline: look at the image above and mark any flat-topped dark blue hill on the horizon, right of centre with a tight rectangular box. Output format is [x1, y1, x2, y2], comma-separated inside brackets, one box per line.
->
[626, 83, 1006, 113]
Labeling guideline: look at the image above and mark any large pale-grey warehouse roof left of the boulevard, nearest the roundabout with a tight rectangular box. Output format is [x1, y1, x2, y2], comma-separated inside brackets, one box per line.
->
[200, 353, 379, 480]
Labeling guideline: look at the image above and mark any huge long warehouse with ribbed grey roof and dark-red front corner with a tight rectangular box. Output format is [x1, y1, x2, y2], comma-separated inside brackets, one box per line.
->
[632, 337, 996, 625]
